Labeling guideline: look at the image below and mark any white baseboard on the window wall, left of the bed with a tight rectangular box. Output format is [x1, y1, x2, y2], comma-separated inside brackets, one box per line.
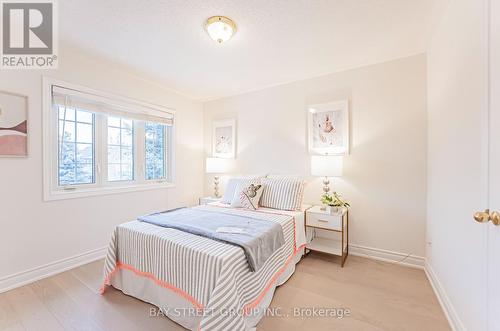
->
[0, 246, 108, 293]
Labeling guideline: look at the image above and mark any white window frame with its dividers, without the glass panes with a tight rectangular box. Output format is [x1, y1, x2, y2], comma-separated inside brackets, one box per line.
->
[42, 77, 176, 201]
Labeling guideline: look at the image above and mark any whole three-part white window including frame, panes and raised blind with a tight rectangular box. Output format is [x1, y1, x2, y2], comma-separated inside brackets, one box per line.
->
[44, 79, 174, 200]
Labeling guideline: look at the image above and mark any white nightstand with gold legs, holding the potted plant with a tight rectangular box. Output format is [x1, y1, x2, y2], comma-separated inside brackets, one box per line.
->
[306, 206, 349, 267]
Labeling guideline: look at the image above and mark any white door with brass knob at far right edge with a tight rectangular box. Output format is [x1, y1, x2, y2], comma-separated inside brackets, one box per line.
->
[484, 0, 500, 331]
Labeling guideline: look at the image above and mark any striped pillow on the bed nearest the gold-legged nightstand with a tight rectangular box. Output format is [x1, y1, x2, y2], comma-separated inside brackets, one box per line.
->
[260, 177, 304, 210]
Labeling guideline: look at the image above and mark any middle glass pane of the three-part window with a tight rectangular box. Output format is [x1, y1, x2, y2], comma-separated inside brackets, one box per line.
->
[108, 117, 134, 181]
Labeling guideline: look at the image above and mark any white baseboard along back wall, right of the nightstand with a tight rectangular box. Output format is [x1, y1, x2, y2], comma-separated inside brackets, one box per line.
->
[349, 244, 425, 269]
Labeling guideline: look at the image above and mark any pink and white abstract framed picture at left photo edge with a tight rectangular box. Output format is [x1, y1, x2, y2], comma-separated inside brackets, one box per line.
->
[0, 91, 29, 157]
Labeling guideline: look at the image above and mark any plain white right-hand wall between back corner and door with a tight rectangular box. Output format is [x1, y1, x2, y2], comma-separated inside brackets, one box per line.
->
[427, 0, 487, 330]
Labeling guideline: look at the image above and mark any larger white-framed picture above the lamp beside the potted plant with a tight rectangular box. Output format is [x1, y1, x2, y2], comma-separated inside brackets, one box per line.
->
[307, 100, 350, 155]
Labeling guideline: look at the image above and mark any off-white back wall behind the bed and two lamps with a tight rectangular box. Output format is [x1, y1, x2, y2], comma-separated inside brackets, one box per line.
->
[204, 55, 427, 256]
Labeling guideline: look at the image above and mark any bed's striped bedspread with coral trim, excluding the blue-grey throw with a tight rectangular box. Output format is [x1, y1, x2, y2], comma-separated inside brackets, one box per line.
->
[102, 204, 305, 330]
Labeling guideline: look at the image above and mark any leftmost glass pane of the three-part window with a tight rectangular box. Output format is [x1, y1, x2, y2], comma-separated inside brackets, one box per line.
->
[58, 111, 95, 186]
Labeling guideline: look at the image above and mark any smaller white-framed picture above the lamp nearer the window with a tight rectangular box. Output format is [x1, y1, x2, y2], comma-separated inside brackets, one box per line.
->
[212, 119, 236, 159]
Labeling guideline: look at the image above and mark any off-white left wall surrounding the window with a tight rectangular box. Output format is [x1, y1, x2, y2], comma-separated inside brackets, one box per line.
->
[0, 48, 204, 280]
